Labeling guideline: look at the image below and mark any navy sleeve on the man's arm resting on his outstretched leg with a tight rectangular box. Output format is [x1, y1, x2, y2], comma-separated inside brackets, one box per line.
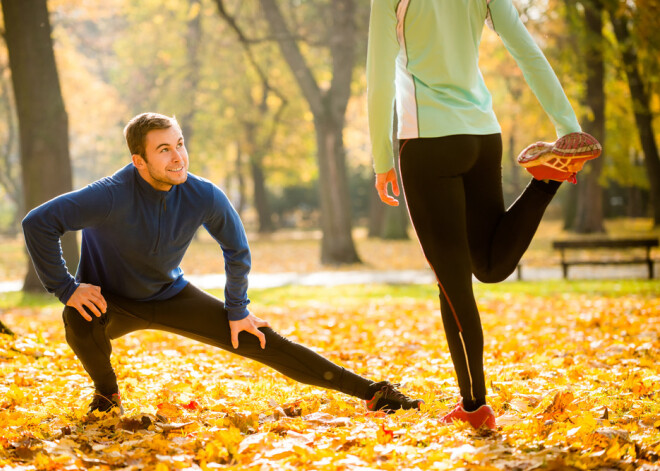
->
[204, 184, 252, 321]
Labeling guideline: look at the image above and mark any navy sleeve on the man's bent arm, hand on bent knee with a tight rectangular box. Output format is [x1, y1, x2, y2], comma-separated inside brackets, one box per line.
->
[22, 182, 112, 304]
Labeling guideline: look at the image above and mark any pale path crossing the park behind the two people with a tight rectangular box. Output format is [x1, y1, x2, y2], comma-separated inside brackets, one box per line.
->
[0, 265, 657, 292]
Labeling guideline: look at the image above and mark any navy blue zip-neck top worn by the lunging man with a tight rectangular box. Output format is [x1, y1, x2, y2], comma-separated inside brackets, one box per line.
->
[23, 163, 251, 320]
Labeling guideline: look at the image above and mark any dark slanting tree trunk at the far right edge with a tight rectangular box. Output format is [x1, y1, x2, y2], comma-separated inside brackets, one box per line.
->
[610, 11, 660, 227]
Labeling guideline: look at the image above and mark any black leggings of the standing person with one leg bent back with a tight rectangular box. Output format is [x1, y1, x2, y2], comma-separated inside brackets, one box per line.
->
[400, 134, 559, 407]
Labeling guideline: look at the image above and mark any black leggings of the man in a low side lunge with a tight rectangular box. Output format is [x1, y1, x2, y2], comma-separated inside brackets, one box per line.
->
[63, 284, 373, 399]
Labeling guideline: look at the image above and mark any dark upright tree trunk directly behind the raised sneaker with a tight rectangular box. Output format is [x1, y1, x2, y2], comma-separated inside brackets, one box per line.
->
[573, 0, 605, 234]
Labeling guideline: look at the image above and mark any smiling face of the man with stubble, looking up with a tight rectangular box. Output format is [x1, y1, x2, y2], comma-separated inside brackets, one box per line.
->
[133, 126, 188, 191]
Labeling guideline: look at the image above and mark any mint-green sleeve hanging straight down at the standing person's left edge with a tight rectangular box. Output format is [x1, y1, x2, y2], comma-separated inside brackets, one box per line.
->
[367, 0, 399, 173]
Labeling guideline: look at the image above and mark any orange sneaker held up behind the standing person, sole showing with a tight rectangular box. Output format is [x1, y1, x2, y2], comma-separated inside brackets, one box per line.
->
[518, 132, 603, 183]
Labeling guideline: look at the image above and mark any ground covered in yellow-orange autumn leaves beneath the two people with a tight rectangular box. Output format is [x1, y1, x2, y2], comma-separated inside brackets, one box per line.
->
[0, 281, 660, 470]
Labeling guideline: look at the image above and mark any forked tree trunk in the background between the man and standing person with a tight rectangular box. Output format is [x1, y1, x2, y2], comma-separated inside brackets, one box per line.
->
[260, 0, 360, 265]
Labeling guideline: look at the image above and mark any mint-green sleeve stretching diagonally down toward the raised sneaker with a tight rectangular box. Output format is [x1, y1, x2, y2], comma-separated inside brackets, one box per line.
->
[489, 0, 581, 137]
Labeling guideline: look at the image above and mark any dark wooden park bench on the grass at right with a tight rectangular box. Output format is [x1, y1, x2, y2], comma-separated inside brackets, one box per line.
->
[552, 238, 658, 280]
